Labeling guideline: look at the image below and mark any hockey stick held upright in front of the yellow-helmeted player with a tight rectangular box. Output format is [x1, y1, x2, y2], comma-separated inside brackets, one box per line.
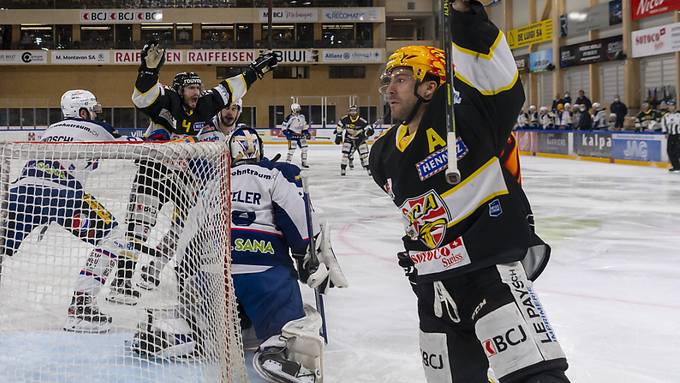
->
[439, 0, 462, 185]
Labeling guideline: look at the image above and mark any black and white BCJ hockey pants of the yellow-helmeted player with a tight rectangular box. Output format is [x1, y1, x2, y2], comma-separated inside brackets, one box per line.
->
[414, 262, 569, 383]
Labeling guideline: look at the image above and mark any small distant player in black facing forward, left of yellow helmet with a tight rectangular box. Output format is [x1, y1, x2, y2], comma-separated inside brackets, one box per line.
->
[335, 105, 373, 176]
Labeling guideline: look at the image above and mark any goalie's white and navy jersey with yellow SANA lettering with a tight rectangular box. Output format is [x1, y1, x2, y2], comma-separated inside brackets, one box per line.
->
[230, 161, 309, 273]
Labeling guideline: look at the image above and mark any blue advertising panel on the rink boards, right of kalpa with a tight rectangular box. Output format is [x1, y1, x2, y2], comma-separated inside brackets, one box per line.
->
[612, 133, 665, 162]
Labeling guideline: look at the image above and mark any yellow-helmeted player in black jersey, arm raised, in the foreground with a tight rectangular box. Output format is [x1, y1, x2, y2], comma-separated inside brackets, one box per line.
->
[369, 0, 568, 383]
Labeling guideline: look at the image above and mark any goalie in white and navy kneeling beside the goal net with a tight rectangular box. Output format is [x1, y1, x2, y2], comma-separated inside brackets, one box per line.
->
[228, 128, 347, 382]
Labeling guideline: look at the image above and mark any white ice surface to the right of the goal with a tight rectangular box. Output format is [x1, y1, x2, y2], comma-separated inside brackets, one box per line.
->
[266, 145, 680, 383]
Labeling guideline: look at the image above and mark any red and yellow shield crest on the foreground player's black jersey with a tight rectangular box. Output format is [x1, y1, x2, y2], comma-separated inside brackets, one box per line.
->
[400, 190, 451, 249]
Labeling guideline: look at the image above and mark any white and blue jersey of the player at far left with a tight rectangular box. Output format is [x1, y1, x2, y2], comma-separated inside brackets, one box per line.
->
[14, 118, 128, 189]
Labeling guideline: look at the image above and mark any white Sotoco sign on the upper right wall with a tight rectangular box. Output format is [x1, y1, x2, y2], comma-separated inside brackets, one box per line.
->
[632, 23, 680, 57]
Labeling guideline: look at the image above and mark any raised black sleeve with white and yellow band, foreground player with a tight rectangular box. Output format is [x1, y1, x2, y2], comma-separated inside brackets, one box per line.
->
[451, 1, 525, 153]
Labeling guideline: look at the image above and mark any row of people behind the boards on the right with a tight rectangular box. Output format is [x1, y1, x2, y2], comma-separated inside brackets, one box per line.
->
[515, 90, 675, 132]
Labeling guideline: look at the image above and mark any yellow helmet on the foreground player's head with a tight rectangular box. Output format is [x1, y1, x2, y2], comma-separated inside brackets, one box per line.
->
[384, 45, 446, 85]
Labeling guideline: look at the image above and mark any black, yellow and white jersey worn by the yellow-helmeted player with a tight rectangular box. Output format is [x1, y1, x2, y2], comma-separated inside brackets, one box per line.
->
[370, 3, 533, 282]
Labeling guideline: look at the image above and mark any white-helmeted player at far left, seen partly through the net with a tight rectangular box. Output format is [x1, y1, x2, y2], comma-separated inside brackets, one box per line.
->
[3, 90, 139, 333]
